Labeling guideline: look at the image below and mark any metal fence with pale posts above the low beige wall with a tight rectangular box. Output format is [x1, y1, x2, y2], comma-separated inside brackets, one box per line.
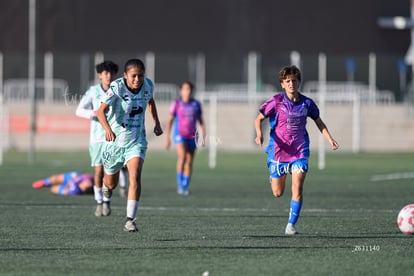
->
[0, 52, 413, 104]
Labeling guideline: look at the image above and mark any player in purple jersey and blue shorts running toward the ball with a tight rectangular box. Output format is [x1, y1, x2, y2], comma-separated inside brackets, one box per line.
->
[254, 66, 339, 235]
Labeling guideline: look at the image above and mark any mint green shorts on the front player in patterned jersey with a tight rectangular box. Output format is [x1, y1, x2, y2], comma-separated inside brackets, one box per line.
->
[102, 143, 147, 175]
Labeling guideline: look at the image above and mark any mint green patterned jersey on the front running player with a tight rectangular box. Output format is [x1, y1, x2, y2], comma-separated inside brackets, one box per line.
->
[101, 78, 154, 148]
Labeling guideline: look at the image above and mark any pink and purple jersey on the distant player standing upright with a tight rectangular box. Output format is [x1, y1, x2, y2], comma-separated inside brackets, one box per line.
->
[170, 99, 202, 139]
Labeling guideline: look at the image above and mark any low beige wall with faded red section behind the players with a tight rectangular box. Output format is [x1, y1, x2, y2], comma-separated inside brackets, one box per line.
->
[5, 102, 414, 152]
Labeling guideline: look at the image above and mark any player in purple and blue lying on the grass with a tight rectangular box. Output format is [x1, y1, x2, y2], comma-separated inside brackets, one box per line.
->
[32, 172, 94, 195]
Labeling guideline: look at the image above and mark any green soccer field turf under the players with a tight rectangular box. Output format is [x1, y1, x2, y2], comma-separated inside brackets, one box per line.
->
[0, 150, 414, 275]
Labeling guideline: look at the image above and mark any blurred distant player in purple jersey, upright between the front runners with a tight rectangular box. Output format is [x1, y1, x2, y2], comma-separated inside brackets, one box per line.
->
[165, 81, 205, 195]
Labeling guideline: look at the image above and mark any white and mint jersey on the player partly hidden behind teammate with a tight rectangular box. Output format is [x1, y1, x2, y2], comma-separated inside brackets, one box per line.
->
[76, 84, 105, 144]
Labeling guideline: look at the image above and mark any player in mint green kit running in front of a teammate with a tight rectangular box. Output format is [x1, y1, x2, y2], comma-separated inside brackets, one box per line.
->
[97, 59, 163, 232]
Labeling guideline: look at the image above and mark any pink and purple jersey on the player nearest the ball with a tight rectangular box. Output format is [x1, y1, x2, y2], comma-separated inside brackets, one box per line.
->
[259, 93, 319, 162]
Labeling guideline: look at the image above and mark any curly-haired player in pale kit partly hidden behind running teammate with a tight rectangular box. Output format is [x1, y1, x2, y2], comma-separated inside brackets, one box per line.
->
[76, 61, 127, 217]
